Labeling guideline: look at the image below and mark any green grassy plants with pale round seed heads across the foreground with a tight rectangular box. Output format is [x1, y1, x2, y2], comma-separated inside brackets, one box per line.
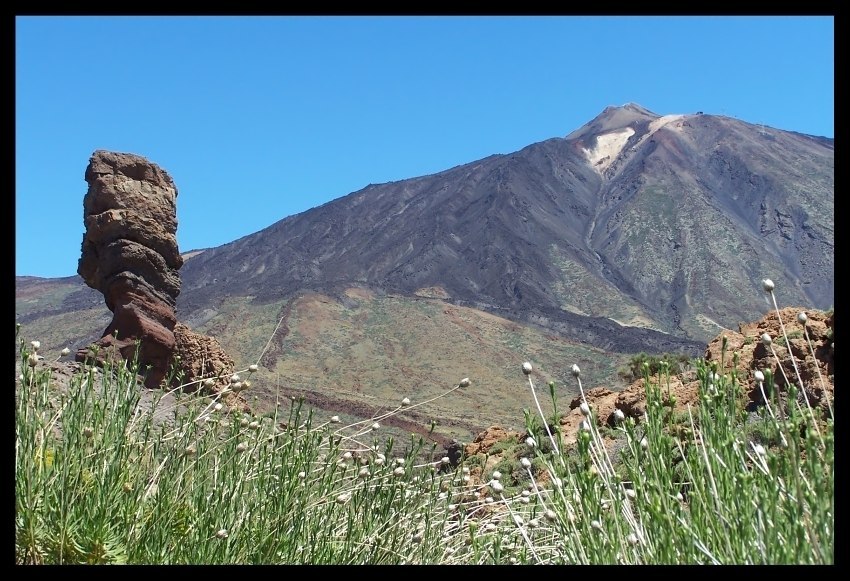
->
[15, 280, 835, 564]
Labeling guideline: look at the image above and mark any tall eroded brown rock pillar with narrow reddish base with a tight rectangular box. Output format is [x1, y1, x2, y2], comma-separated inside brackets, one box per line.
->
[76, 151, 233, 394]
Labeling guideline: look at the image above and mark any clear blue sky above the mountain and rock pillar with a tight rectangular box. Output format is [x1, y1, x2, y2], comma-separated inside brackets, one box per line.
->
[15, 16, 835, 277]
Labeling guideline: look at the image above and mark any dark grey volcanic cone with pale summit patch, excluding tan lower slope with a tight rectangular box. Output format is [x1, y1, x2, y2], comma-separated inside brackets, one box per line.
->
[179, 104, 834, 350]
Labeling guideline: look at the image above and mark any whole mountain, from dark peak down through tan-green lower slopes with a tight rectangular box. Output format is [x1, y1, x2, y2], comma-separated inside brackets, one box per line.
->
[16, 104, 834, 440]
